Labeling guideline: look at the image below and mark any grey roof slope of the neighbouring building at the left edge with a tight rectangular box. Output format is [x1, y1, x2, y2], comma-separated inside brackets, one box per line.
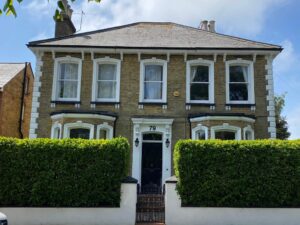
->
[0, 63, 25, 89]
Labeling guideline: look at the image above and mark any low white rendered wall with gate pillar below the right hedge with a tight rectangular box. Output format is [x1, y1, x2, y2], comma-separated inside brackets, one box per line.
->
[165, 183, 300, 225]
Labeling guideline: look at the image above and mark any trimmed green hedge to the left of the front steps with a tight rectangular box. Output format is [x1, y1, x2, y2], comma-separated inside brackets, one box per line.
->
[0, 138, 130, 207]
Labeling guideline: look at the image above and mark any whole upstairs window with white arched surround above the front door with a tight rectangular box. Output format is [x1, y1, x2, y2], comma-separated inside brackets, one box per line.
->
[139, 58, 167, 103]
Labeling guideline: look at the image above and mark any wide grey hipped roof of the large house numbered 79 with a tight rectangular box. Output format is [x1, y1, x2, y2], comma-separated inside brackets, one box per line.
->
[28, 22, 282, 51]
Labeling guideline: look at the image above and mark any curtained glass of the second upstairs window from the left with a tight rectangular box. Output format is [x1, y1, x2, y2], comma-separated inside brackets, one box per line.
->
[97, 64, 117, 99]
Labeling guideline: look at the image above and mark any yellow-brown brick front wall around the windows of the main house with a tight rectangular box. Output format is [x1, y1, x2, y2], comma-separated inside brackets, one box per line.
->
[37, 52, 269, 143]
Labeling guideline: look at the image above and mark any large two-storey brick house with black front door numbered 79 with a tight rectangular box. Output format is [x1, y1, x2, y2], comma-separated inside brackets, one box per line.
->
[28, 4, 282, 192]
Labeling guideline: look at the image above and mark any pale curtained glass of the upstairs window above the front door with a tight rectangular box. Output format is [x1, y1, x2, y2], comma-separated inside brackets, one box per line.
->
[144, 65, 163, 100]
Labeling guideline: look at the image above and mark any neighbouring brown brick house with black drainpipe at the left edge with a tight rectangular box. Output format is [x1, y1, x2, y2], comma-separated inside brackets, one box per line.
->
[0, 63, 34, 138]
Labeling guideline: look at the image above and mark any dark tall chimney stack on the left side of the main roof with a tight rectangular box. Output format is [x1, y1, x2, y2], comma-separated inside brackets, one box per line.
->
[55, 0, 76, 38]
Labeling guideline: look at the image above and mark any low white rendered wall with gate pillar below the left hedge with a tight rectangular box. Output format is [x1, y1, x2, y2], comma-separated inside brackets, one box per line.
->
[0, 184, 137, 225]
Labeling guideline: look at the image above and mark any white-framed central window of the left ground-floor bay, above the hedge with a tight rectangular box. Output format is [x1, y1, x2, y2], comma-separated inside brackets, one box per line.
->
[64, 121, 94, 139]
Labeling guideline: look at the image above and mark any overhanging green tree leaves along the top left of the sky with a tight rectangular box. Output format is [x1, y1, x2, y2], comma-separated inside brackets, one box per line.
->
[0, 0, 101, 20]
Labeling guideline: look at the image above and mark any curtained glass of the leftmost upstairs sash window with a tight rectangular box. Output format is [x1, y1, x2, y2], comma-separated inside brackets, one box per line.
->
[58, 63, 78, 98]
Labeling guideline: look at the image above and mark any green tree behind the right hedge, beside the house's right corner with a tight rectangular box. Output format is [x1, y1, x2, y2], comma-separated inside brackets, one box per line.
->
[275, 94, 291, 140]
